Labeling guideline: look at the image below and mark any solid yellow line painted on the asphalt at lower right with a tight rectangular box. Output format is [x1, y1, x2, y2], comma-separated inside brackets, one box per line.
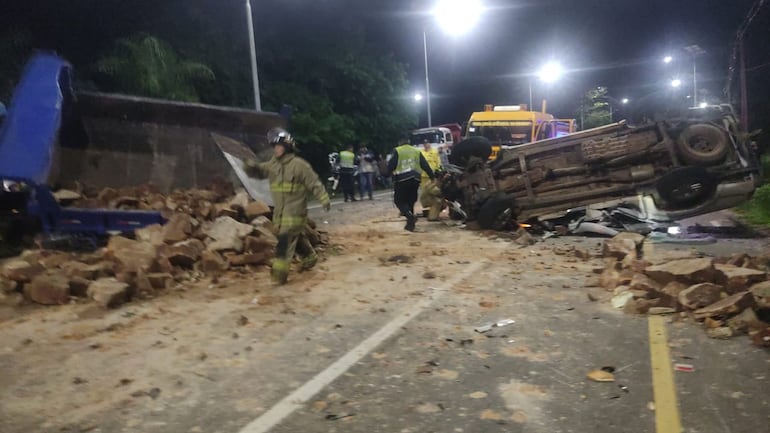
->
[649, 316, 682, 433]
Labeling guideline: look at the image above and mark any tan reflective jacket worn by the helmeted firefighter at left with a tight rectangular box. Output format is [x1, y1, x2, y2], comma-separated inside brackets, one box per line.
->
[244, 153, 329, 233]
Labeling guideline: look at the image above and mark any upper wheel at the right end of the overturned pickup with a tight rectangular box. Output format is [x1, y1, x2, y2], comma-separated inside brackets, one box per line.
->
[676, 124, 730, 165]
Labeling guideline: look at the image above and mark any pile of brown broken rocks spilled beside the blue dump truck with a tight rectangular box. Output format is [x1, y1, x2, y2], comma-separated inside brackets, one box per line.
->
[0, 182, 325, 307]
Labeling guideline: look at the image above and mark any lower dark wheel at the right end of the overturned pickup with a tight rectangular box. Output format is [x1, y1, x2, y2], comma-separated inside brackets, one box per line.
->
[656, 167, 717, 209]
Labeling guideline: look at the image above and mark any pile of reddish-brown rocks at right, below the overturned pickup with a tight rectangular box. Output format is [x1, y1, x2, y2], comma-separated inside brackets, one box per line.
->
[600, 233, 770, 347]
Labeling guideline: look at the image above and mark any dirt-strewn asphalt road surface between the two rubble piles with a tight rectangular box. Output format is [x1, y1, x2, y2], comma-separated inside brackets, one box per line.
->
[0, 194, 770, 433]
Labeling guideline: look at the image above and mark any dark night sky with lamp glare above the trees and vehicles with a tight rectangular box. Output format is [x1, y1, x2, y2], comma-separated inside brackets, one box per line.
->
[6, 0, 770, 124]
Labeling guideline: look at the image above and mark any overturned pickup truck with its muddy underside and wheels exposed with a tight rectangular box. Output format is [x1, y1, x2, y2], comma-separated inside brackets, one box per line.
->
[442, 105, 760, 230]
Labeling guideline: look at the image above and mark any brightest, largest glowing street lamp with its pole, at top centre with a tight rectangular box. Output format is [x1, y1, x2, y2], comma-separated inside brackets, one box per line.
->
[422, 0, 484, 127]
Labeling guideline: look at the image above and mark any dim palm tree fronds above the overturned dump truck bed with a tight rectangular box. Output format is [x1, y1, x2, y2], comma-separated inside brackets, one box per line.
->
[95, 34, 214, 102]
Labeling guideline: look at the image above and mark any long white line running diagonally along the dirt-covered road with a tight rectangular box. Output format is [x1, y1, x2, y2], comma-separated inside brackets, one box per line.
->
[239, 263, 485, 433]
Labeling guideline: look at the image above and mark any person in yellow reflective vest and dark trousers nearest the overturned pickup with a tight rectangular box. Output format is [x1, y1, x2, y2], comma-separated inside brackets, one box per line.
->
[388, 143, 433, 232]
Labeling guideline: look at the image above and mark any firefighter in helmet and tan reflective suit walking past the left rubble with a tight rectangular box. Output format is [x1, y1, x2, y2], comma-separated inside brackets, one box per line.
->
[244, 128, 331, 284]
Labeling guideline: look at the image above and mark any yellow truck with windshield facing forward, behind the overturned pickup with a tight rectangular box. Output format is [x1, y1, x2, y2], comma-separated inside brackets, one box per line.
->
[465, 104, 575, 160]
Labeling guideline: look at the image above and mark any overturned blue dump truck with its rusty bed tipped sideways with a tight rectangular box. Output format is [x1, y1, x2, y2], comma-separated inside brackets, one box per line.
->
[0, 54, 285, 250]
